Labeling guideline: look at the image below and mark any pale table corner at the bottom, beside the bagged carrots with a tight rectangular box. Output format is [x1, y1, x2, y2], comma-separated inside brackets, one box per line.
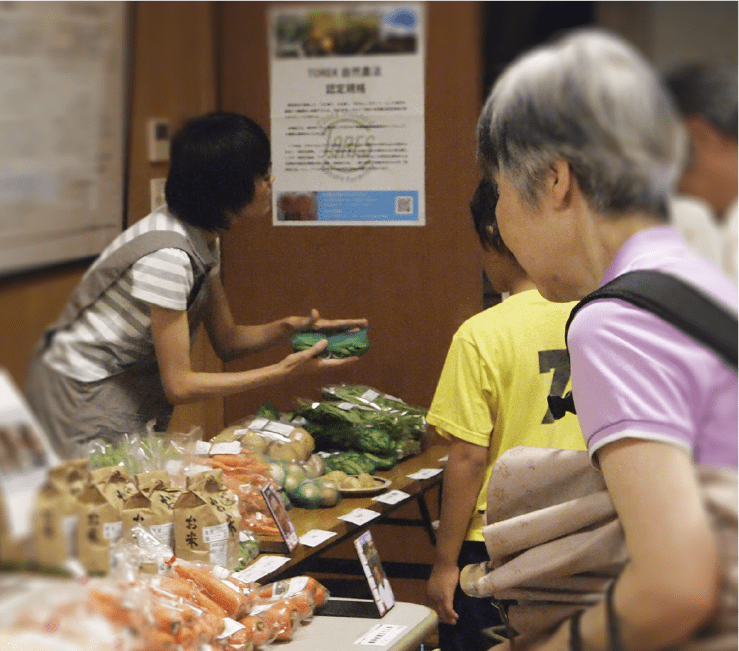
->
[279, 602, 437, 651]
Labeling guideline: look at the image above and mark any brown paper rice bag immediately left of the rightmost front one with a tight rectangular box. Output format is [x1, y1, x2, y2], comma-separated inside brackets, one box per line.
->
[121, 470, 182, 550]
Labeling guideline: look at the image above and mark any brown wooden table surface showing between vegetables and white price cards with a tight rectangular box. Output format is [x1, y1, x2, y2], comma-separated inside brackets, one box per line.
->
[246, 444, 448, 583]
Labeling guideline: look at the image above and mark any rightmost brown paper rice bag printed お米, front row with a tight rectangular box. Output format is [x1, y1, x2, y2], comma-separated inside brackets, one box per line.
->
[174, 469, 239, 570]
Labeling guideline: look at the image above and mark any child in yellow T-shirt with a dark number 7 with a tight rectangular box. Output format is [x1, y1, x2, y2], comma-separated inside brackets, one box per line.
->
[427, 180, 585, 651]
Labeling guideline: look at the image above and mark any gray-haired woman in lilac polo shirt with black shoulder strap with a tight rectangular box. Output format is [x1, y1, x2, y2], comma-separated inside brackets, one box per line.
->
[478, 30, 739, 650]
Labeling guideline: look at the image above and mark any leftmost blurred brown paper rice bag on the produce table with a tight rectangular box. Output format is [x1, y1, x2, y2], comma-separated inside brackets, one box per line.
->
[32, 459, 89, 567]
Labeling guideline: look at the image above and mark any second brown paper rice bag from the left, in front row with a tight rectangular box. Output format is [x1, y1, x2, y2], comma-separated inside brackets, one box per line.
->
[77, 466, 136, 573]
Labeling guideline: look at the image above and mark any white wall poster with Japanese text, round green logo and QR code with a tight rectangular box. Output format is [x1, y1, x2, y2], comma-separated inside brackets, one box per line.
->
[269, 1, 426, 226]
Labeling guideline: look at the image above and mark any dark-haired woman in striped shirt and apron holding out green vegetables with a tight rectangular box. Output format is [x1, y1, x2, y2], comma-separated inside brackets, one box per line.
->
[26, 112, 367, 457]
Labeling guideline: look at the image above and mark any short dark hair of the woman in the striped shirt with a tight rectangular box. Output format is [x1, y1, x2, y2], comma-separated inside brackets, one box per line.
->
[164, 111, 271, 231]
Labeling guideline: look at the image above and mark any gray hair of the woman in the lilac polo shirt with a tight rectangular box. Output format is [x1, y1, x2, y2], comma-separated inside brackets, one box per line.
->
[477, 29, 687, 216]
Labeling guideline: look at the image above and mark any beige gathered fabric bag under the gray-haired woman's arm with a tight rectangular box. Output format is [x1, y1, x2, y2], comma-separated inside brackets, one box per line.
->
[460, 447, 739, 651]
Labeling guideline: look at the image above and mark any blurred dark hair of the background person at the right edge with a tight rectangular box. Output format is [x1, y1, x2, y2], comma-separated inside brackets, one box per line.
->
[666, 62, 739, 140]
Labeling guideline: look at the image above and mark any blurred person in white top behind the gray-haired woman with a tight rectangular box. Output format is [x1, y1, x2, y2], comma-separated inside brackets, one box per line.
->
[666, 63, 739, 282]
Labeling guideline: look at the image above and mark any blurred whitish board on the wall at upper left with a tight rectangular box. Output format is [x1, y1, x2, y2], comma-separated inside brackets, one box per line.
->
[0, 0, 127, 275]
